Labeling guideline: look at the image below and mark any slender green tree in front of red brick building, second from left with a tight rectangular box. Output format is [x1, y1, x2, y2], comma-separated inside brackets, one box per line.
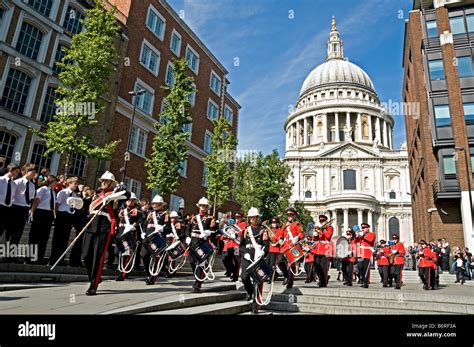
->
[145, 59, 195, 195]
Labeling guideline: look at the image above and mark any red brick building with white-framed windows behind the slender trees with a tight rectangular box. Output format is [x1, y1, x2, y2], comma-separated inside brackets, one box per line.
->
[106, 0, 240, 216]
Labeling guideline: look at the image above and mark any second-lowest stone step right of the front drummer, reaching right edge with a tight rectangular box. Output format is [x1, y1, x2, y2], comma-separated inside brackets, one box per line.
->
[272, 294, 474, 314]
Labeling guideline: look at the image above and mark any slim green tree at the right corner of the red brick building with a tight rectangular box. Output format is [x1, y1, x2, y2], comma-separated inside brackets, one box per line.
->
[206, 117, 237, 214]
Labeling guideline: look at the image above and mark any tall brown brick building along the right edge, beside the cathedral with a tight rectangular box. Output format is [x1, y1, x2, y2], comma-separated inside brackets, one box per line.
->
[403, 0, 474, 249]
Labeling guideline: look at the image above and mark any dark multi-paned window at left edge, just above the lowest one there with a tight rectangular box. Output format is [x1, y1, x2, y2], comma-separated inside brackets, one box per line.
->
[0, 69, 31, 114]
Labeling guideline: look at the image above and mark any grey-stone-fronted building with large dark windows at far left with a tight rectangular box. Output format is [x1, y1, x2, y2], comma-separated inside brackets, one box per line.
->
[0, 0, 128, 185]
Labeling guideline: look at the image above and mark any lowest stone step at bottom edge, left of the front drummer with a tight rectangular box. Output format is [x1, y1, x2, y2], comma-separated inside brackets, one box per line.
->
[144, 301, 252, 315]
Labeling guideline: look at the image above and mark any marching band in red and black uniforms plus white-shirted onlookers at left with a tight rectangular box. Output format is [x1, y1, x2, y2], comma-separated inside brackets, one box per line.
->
[0, 165, 452, 313]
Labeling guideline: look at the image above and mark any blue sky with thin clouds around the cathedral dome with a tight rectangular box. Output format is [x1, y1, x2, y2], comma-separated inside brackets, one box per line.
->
[168, 0, 411, 156]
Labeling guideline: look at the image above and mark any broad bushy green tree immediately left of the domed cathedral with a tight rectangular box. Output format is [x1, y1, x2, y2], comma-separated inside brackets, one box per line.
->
[236, 150, 293, 220]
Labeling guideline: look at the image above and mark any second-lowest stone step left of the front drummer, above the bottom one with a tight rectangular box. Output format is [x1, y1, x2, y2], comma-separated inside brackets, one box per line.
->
[103, 284, 241, 314]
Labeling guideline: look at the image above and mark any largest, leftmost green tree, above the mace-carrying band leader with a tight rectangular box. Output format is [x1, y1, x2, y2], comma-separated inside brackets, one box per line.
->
[32, 0, 120, 173]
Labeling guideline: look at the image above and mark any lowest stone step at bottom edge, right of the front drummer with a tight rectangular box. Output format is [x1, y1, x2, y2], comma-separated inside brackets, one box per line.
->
[265, 302, 445, 315]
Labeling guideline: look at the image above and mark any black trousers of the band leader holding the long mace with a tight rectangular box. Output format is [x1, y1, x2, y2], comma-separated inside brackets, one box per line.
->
[82, 228, 112, 289]
